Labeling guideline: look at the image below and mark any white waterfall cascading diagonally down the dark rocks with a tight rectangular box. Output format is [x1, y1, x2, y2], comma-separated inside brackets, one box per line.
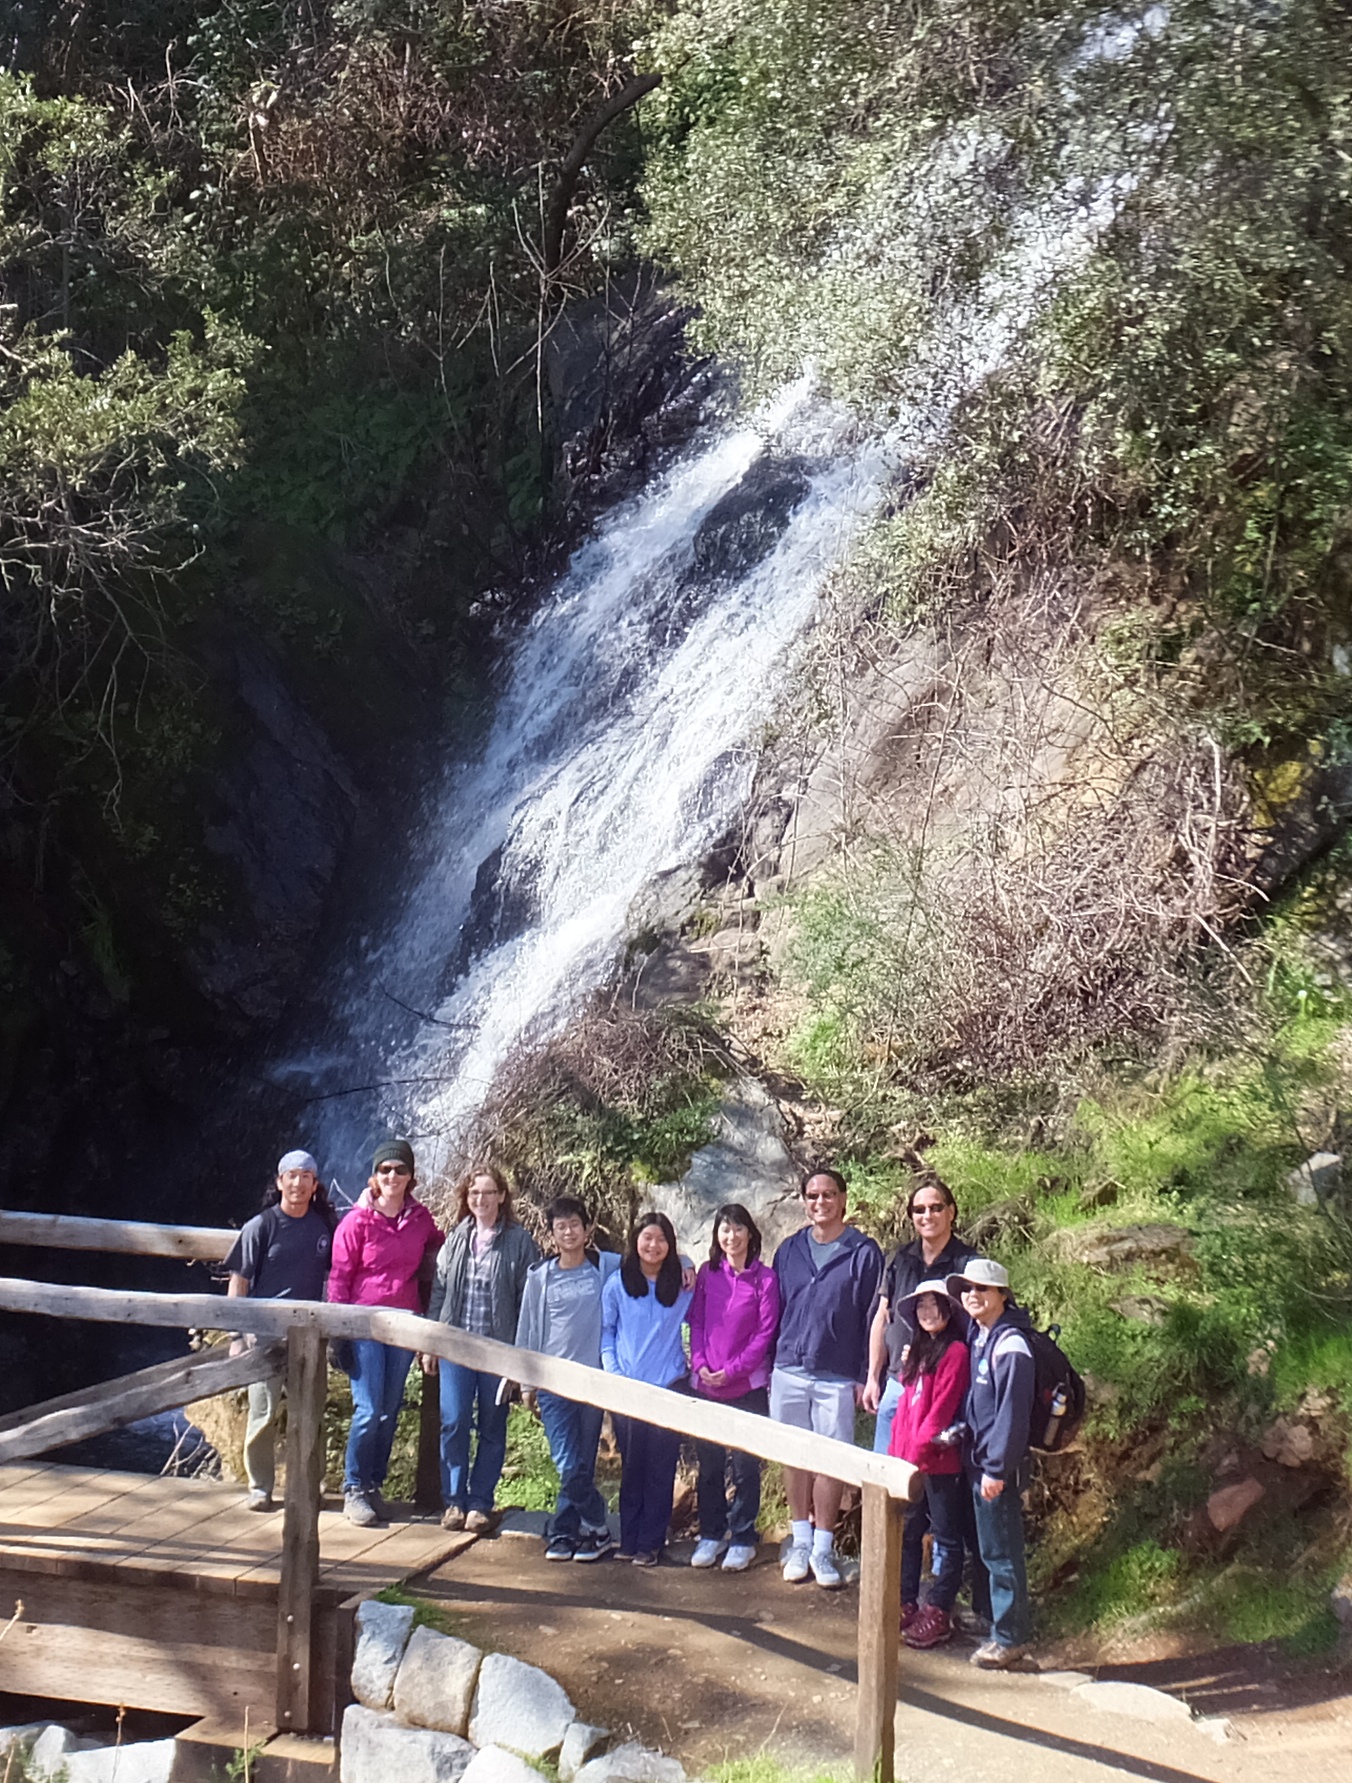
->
[276, 17, 1167, 1177]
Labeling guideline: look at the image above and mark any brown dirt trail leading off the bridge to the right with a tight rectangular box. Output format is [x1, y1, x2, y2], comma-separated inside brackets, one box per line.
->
[410, 1535, 1352, 1783]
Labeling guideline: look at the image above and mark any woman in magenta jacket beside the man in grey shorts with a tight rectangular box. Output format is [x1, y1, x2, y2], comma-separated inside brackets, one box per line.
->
[690, 1202, 779, 1573]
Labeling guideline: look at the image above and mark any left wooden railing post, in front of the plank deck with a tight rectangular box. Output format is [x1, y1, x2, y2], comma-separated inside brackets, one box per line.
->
[276, 1325, 328, 1733]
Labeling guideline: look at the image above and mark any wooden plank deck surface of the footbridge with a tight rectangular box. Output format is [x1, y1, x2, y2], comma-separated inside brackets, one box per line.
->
[0, 1462, 466, 1619]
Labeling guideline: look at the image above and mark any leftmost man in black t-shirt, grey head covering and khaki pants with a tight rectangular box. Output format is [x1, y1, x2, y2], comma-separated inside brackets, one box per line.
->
[225, 1152, 334, 1510]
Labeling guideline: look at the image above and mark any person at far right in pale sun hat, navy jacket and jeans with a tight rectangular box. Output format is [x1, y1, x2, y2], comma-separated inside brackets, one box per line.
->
[947, 1257, 1035, 1671]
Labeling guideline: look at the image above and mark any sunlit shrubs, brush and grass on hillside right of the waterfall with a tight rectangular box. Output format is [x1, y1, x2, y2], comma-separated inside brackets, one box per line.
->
[631, 0, 1352, 1651]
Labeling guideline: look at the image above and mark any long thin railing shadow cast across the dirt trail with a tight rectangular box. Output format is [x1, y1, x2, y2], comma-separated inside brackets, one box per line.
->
[405, 1569, 1209, 1783]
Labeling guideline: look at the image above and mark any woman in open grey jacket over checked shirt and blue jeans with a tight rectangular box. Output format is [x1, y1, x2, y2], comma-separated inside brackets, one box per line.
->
[423, 1164, 540, 1533]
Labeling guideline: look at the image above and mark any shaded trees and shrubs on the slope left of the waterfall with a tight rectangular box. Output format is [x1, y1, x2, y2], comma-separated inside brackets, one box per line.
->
[0, 0, 652, 1002]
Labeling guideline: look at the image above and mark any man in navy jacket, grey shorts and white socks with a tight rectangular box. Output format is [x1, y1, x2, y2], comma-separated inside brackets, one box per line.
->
[771, 1170, 883, 1590]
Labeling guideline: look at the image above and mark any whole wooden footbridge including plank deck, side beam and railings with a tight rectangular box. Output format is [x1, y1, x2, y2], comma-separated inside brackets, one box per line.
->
[0, 1212, 922, 1783]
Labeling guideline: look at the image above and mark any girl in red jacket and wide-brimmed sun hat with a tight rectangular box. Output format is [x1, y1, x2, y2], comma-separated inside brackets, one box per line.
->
[888, 1282, 969, 1647]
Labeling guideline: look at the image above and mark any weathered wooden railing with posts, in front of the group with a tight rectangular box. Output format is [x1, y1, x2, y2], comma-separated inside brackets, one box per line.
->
[0, 1212, 924, 1783]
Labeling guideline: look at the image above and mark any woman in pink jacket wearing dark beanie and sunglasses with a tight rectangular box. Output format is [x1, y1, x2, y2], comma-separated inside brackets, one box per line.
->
[325, 1139, 441, 1528]
